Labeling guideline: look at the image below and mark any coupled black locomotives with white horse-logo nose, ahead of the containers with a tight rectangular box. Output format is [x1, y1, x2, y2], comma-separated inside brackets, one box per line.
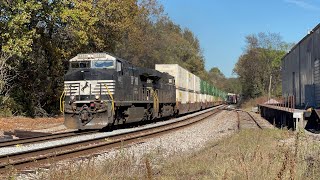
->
[61, 53, 178, 129]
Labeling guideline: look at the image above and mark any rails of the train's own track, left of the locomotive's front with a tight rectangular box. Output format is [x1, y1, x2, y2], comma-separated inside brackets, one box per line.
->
[0, 130, 98, 148]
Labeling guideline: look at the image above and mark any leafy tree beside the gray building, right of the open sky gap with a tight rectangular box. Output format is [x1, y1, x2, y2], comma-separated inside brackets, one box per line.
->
[234, 33, 292, 98]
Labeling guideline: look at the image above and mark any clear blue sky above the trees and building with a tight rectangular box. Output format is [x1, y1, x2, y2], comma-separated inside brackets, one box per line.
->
[159, 0, 320, 77]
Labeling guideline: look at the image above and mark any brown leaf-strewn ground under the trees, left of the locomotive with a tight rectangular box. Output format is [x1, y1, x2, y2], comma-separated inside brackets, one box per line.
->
[0, 117, 63, 132]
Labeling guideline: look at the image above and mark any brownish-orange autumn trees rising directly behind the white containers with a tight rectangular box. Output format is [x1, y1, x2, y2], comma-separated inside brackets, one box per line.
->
[116, 0, 205, 76]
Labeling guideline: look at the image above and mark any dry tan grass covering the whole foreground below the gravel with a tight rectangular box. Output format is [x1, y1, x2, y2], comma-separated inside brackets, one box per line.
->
[6, 129, 320, 180]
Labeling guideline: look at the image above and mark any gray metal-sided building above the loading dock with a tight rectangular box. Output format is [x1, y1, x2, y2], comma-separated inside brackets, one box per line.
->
[281, 24, 320, 108]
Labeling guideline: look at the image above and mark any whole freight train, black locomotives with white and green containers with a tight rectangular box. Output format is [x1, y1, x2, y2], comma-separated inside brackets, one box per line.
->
[60, 53, 226, 129]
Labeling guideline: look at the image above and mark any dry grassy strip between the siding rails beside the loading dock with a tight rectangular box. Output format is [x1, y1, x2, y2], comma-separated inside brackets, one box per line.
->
[236, 110, 263, 130]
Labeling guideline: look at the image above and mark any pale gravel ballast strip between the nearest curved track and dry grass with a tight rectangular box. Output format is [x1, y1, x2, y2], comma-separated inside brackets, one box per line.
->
[18, 111, 237, 179]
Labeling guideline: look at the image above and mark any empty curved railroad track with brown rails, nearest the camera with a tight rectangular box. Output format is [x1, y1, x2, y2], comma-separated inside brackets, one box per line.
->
[0, 106, 225, 174]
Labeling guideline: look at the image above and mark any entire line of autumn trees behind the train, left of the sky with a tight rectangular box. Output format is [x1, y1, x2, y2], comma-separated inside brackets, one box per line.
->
[0, 0, 215, 117]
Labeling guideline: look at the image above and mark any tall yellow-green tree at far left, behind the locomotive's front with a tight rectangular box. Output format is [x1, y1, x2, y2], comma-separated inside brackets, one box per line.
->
[0, 0, 137, 116]
